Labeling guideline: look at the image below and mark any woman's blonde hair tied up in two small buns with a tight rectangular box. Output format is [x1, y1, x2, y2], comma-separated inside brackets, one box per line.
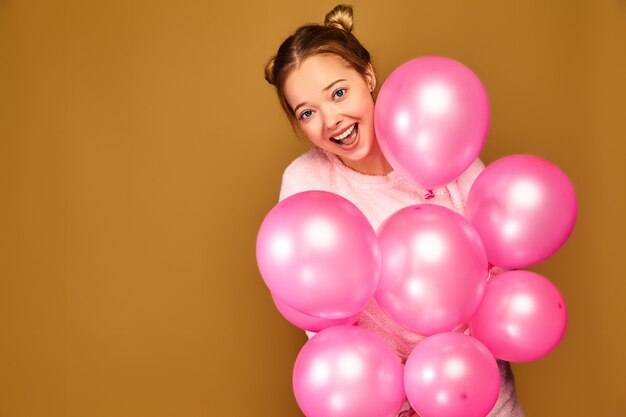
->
[265, 4, 373, 136]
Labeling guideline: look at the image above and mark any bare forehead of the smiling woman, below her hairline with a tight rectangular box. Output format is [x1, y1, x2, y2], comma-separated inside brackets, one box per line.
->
[284, 55, 361, 106]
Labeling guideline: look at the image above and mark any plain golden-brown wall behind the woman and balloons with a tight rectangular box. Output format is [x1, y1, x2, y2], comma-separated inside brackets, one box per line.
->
[0, 0, 626, 417]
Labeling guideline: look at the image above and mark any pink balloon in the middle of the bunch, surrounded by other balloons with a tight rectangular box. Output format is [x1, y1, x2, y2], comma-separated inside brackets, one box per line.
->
[374, 204, 489, 336]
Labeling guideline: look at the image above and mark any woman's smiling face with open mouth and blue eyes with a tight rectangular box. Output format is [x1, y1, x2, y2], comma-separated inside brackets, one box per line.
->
[284, 55, 376, 163]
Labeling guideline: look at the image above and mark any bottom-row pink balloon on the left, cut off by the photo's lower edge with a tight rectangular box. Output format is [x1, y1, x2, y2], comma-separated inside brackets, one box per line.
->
[293, 326, 406, 417]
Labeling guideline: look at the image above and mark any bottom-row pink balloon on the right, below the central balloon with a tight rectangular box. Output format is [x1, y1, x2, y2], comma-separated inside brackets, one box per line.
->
[404, 333, 500, 417]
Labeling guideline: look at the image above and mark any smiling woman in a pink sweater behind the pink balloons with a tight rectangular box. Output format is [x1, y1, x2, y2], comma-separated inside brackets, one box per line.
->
[265, 5, 523, 417]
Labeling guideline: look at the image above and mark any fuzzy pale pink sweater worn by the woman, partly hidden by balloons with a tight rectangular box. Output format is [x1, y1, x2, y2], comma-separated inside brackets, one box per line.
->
[279, 148, 524, 417]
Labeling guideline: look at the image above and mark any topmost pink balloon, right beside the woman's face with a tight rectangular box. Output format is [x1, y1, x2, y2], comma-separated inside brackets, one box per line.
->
[374, 57, 489, 189]
